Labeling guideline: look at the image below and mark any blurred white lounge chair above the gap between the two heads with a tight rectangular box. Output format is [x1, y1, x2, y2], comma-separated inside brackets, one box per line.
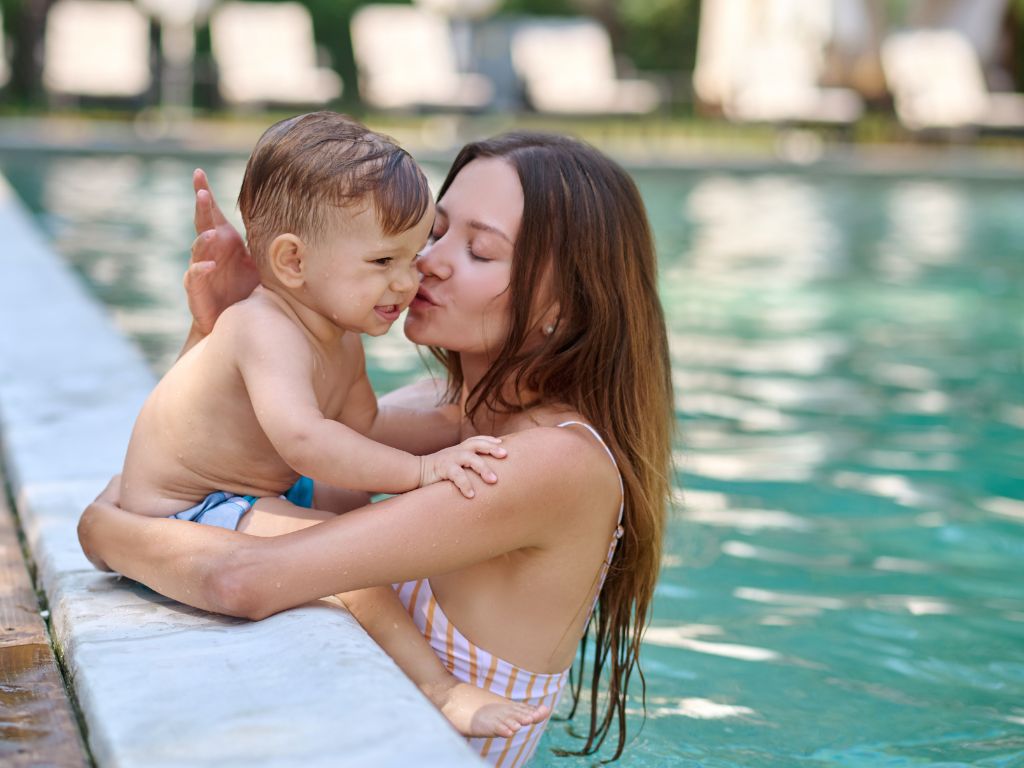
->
[349, 4, 494, 110]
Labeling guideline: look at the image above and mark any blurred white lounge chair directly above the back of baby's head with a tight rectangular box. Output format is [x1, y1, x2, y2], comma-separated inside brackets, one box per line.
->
[210, 2, 342, 106]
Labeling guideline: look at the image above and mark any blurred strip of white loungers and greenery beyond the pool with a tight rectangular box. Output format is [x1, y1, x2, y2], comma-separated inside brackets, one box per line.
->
[0, 0, 1024, 148]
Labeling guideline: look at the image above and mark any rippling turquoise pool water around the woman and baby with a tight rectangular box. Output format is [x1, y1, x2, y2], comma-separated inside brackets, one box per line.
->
[0, 156, 1024, 768]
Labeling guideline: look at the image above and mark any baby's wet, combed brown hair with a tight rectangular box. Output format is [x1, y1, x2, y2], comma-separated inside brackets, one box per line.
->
[239, 112, 431, 264]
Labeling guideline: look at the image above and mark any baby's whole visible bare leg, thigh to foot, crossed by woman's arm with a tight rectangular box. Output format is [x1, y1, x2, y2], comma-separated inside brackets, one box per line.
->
[239, 499, 550, 738]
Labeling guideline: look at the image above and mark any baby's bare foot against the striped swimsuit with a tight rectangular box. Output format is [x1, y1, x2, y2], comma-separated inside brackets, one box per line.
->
[424, 682, 551, 738]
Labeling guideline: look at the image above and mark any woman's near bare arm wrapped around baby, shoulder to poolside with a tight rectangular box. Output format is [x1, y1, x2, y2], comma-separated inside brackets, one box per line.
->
[79, 429, 593, 618]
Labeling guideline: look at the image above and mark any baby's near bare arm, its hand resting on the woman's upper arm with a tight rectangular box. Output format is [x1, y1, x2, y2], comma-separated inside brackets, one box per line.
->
[233, 305, 505, 497]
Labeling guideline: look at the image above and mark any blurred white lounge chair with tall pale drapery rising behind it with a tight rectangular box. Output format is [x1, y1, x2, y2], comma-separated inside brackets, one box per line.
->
[693, 0, 863, 124]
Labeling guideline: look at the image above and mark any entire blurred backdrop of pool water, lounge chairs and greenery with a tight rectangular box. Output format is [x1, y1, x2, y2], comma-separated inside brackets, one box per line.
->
[0, 0, 1024, 768]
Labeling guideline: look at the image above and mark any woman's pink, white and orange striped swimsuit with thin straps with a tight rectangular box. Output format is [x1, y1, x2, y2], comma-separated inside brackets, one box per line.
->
[392, 421, 623, 768]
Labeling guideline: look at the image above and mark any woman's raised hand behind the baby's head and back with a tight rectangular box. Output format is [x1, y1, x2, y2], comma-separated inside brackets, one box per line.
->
[185, 168, 259, 335]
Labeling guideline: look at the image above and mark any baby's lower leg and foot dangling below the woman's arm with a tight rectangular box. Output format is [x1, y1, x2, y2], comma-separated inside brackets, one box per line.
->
[338, 587, 551, 738]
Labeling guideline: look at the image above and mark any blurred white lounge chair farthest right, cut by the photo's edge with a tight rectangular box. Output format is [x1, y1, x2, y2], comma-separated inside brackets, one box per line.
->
[882, 30, 1024, 130]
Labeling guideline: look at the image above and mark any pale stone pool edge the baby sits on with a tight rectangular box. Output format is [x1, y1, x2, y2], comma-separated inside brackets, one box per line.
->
[0, 176, 481, 768]
